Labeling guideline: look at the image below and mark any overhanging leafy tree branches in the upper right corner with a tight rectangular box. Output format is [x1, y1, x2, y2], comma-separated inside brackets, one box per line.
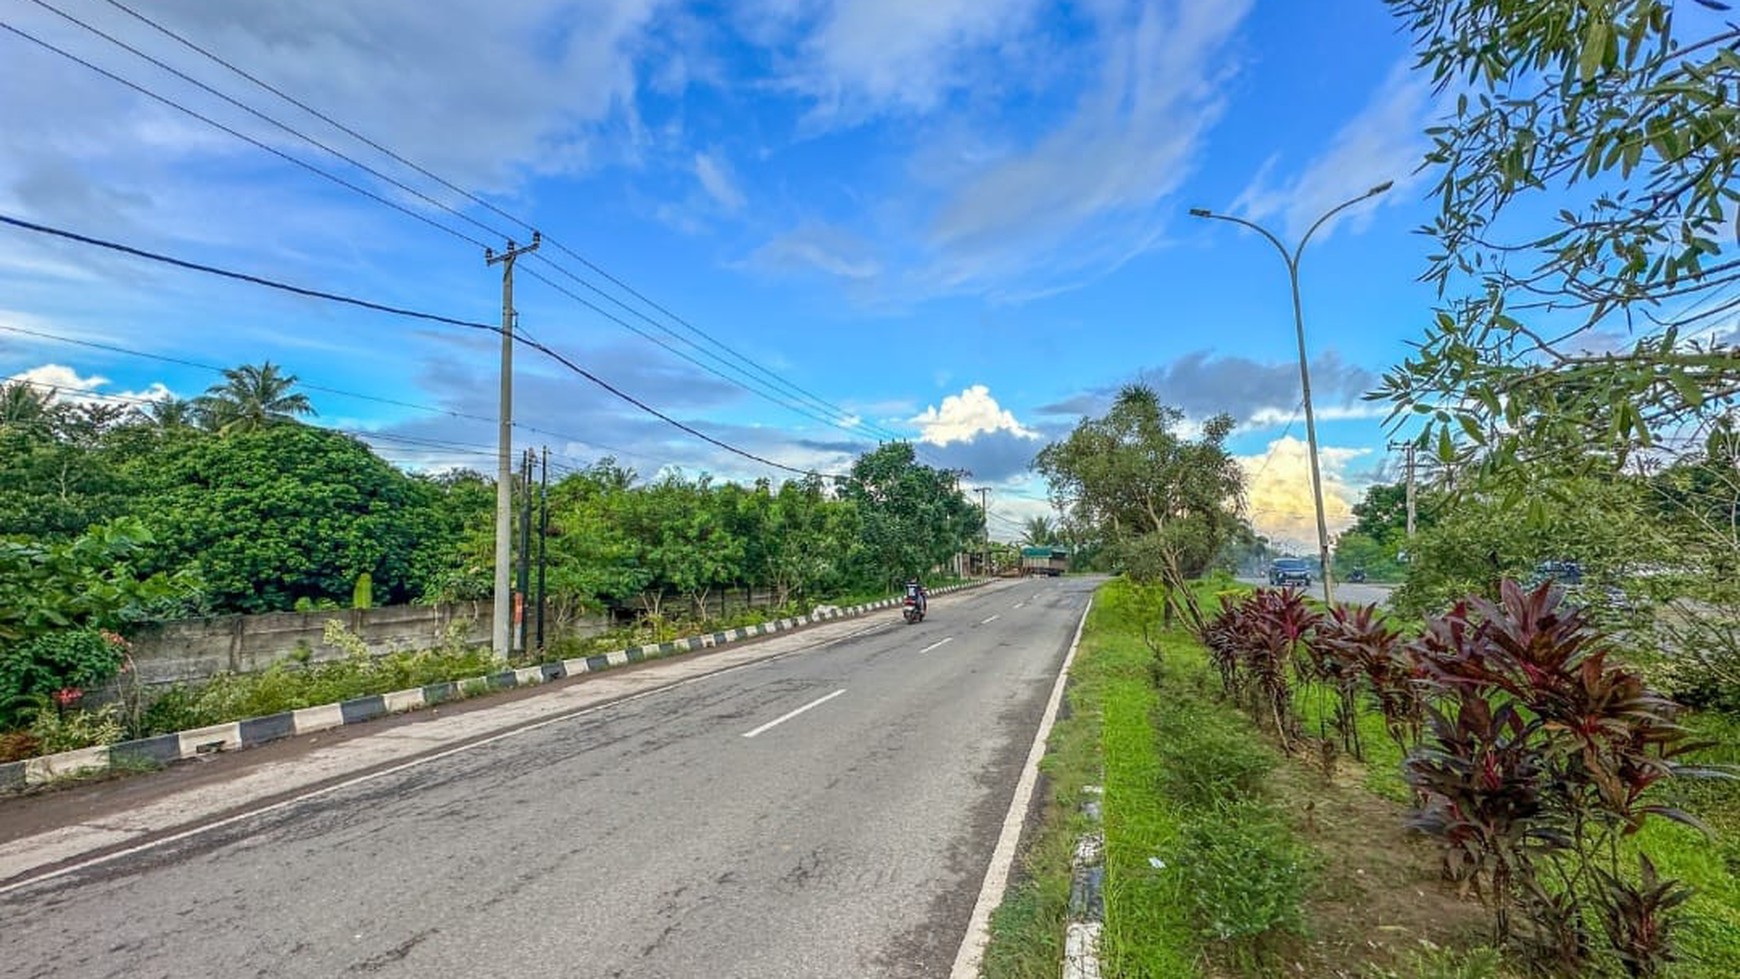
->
[1378, 0, 1740, 475]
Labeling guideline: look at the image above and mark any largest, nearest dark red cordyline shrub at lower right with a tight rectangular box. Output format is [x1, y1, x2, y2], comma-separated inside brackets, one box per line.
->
[1404, 581, 1697, 976]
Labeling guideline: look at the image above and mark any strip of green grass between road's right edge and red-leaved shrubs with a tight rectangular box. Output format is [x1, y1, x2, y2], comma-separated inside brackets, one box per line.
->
[985, 581, 1312, 979]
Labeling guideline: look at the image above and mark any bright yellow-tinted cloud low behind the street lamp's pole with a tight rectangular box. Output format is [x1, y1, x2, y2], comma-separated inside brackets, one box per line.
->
[1237, 436, 1371, 551]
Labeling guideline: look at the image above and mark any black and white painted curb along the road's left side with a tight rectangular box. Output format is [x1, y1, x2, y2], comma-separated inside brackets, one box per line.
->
[0, 581, 985, 793]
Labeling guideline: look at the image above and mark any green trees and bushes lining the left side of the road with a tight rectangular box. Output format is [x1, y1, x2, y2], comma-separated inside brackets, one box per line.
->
[0, 372, 983, 758]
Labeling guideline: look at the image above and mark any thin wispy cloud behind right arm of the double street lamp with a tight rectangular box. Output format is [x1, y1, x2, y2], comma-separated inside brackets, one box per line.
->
[1232, 61, 1432, 242]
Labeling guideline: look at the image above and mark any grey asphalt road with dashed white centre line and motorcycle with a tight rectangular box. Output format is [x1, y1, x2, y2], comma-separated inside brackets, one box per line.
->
[0, 579, 1094, 979]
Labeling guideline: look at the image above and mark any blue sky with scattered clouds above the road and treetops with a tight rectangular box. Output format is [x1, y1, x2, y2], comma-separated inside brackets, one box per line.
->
[0, 0, 1454, 541]
